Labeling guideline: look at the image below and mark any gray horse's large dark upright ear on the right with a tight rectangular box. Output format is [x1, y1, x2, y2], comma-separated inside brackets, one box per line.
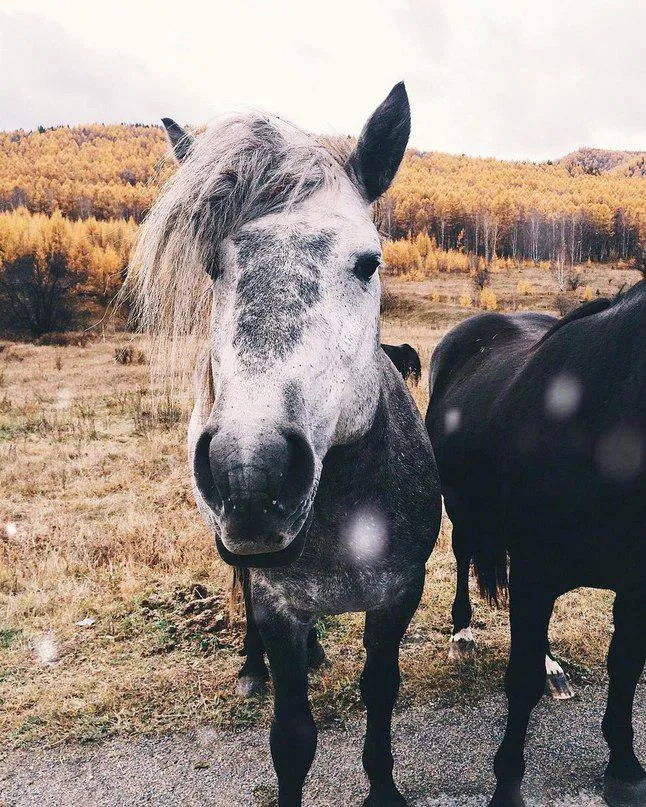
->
[346, 81, 410, 202]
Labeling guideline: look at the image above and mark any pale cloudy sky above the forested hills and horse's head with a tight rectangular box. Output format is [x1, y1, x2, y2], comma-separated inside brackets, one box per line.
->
[0, 0, 646, 160]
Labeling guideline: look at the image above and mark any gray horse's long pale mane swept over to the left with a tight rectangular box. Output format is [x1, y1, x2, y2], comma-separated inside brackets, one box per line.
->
[124, 113, 352, 392]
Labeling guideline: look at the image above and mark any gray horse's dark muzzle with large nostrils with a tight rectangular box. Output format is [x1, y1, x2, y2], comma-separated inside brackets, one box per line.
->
[194, 427, 315, 565]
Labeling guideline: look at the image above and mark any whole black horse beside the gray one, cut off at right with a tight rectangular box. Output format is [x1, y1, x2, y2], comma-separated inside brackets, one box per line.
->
[426, 290, 646, 807]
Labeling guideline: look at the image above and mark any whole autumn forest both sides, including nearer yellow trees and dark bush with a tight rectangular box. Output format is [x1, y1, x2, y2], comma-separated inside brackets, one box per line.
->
[0, 124, 646, 337]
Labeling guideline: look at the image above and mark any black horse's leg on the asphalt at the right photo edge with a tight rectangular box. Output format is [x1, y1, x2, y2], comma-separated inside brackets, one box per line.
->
[603, 592, 646, 807]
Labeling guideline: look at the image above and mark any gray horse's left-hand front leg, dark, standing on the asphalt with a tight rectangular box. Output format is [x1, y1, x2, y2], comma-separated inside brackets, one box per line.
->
[254, 600, 316, 807]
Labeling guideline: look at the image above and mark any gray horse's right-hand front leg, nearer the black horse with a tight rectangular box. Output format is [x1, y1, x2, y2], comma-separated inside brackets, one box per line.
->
[361, 577, 424, 807]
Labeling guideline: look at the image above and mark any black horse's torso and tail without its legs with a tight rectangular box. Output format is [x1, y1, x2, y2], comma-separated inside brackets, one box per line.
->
[426, 282, 646, 594]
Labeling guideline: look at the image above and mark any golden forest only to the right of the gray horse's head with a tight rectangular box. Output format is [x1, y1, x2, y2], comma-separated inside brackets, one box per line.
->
[383, 151, 646, 264]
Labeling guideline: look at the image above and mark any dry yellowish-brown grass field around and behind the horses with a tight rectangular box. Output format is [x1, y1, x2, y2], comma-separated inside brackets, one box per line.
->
[0, 267, 636, 747]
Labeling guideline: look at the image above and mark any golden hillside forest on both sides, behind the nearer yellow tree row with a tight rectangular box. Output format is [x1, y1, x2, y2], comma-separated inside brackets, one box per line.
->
[0, 124, 646, 263]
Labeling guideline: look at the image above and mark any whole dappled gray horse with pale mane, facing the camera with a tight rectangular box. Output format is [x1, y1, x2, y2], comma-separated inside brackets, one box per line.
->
[130, 83, 441, 807]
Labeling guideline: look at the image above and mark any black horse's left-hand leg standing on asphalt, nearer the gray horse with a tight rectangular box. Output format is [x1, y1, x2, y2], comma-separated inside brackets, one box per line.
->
[489, 562, 556, 807]
